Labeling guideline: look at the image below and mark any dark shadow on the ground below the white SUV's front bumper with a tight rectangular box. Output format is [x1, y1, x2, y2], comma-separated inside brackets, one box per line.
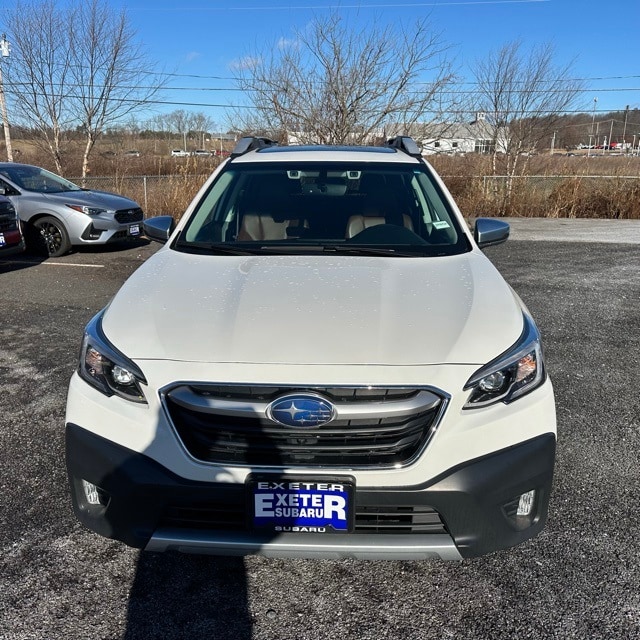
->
[124, 552, 252, 640]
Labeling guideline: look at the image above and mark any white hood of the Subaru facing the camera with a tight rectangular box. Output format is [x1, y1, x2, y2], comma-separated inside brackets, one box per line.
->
[103, 248, 523, 365]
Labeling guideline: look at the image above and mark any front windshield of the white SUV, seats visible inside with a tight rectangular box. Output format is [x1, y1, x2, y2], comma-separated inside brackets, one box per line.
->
[174, 162, 470, 256]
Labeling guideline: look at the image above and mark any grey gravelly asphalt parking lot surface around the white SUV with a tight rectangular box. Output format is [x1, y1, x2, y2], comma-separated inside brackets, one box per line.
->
[0, 220, 640, 640]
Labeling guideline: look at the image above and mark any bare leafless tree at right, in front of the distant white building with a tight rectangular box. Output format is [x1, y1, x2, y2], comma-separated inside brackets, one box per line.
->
[473, 41, 585, 193]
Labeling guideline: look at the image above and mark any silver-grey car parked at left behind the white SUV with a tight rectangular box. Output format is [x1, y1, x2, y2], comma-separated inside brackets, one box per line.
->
[0, 162, 144, 257]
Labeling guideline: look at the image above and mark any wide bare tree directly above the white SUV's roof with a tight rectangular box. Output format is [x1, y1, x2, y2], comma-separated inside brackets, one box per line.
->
[231, 14, 453, 144]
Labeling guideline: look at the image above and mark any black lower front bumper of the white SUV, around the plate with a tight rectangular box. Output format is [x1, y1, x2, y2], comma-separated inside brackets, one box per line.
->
[66, 423, 556, 560]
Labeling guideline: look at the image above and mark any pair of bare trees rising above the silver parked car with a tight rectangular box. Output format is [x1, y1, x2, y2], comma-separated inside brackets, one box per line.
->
[7, 0, 164, 177]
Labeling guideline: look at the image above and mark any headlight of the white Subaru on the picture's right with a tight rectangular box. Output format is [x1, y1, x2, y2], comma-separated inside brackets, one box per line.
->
[464, 313, 546, 409]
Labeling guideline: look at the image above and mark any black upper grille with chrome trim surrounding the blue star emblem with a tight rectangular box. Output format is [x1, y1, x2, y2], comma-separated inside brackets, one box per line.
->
[163, 385, 444, 468]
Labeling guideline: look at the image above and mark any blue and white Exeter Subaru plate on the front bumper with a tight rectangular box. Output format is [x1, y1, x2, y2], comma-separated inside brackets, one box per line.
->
[248, 476, 355, 533]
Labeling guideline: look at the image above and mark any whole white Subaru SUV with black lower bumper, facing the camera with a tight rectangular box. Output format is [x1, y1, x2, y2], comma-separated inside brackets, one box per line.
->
[66, 138, 556, 559]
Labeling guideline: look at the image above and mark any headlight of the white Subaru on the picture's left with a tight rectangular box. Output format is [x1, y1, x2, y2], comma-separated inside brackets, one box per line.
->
[78, 311, 147, 404]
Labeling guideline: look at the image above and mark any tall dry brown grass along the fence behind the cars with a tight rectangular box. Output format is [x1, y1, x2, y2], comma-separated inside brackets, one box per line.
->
[5, 140, 640, 219]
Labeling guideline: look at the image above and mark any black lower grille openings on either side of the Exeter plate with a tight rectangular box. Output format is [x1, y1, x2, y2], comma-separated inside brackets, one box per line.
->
[158, 502, 446, 535]
